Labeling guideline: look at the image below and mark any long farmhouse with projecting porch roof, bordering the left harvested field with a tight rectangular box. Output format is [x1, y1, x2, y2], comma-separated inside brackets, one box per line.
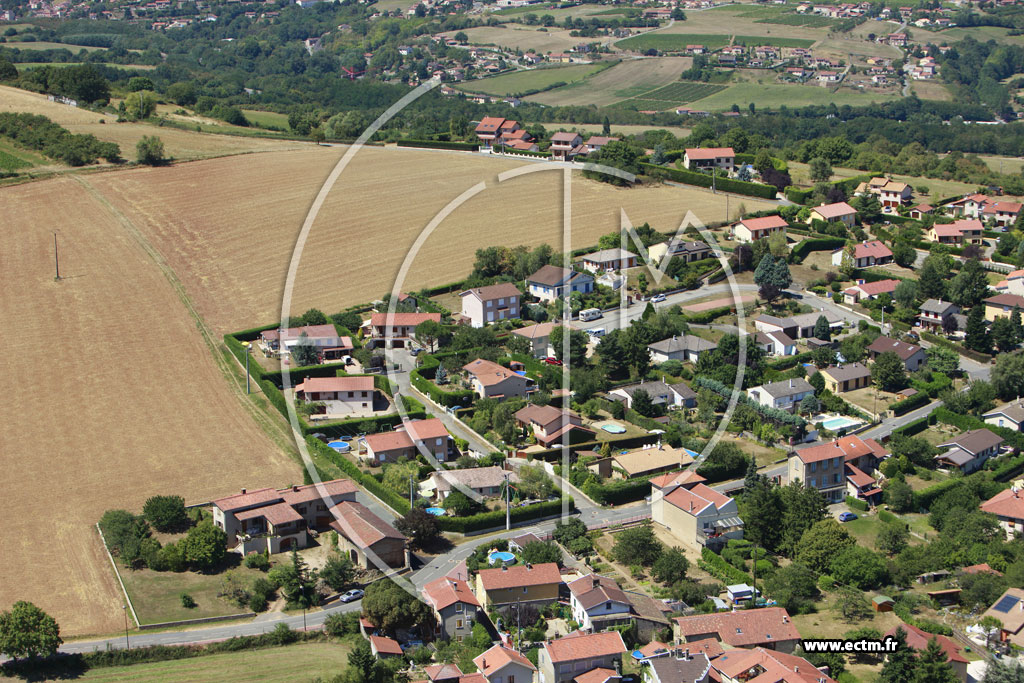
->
[212, 479, 358, 555]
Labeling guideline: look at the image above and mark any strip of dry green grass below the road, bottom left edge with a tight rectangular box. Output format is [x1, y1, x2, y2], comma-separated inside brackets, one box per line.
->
[67, 643, 351, 683]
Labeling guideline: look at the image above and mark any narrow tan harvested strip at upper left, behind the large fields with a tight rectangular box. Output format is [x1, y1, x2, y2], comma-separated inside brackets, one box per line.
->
[0, 86, 309, 160]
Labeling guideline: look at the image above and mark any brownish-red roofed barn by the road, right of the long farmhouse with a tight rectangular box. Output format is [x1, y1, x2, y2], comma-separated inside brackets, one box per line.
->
[331, 501, 408, 571]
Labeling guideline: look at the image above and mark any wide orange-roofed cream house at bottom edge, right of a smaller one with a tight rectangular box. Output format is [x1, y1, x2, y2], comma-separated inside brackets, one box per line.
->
[537, 631, 627, 683]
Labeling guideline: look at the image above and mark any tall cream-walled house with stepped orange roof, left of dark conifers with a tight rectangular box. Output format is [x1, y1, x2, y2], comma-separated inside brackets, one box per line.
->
[650, 475, 743, 550]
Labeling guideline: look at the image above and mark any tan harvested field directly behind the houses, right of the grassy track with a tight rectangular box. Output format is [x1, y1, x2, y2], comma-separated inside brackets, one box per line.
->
[90, 147, 771, 333]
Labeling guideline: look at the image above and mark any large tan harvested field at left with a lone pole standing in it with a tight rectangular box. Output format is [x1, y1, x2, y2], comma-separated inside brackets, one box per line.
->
[0, 177, 301, 635]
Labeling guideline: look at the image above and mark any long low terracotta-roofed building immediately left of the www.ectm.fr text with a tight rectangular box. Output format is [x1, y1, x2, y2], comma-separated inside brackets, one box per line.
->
[674, 607, 800, 658]
